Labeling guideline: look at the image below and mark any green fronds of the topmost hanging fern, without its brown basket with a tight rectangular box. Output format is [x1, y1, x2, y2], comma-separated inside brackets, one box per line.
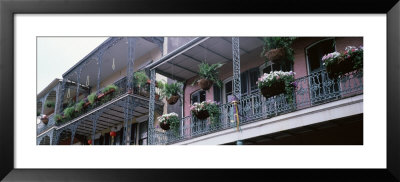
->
[261, 37, 297, 64]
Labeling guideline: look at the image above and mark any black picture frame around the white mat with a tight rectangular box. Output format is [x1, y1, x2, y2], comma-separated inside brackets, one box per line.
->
[0, 0, 400, 181]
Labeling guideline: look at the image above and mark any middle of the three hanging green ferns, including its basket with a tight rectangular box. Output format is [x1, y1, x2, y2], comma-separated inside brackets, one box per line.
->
[192, 62, 223, 90]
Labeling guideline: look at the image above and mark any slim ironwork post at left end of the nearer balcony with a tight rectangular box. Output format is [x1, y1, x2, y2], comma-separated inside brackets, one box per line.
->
[147, 69, 156, 145]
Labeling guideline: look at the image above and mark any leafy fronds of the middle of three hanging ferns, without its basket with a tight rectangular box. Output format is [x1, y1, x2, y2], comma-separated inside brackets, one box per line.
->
[192, 62, 223, 88]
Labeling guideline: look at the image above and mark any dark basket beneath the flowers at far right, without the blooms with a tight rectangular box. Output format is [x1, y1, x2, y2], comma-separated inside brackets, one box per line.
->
[326, 59, 354, 79]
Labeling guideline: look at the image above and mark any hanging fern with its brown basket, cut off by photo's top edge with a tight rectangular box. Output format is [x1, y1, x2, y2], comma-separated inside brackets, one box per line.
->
[261, 37, 296, 63]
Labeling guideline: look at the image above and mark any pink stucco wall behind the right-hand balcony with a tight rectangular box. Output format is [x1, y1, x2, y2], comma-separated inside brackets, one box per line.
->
[183, 37, 363, 116]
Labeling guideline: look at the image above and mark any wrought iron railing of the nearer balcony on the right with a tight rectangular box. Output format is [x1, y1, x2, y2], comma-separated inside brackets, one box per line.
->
[150, 71, 363, 145]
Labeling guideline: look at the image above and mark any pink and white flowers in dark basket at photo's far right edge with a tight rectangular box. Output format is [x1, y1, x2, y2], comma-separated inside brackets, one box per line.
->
[322, 46, 363, 79]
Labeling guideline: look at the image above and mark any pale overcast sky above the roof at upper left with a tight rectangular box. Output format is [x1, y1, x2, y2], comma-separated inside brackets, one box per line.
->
[36, 37, 108, 93]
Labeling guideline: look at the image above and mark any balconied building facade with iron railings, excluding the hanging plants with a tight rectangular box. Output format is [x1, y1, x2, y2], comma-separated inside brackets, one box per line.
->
[37, 37, 363, 145]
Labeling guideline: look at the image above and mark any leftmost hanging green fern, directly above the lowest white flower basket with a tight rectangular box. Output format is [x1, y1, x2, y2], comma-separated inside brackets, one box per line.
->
[160, 82, 183, 105]
